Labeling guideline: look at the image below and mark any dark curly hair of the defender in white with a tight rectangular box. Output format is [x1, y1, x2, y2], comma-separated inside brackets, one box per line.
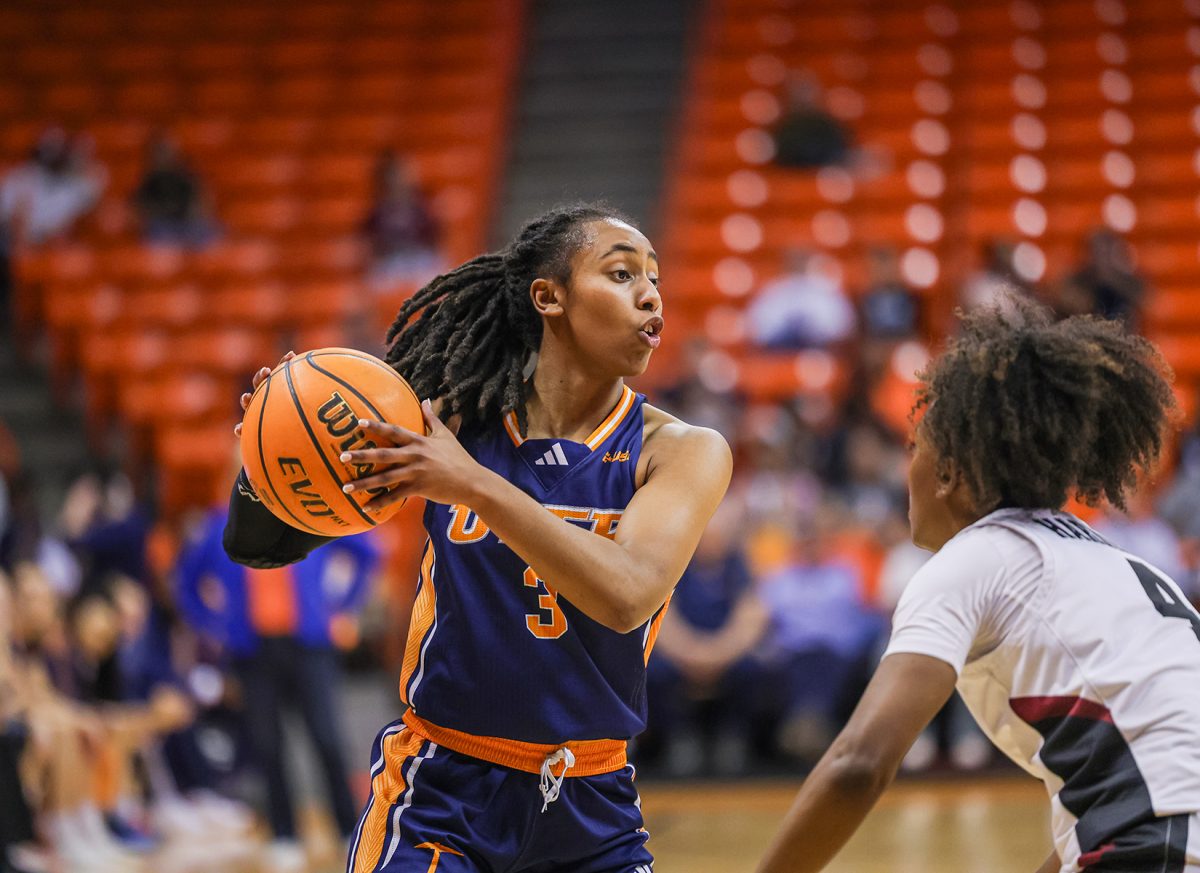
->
[917, 297, 1176, 512]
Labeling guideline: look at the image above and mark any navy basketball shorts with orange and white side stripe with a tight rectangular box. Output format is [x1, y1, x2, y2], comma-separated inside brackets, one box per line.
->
[347, 721, 654, 873]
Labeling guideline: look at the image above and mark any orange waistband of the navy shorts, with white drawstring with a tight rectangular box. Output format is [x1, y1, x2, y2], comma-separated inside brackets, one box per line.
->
[404, 710, 626, 776]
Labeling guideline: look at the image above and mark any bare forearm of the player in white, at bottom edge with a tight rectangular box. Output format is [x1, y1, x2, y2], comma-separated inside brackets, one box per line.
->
[758, 746, 893, 873]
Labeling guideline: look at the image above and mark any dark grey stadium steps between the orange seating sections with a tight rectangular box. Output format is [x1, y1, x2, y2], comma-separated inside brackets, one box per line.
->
[497, 0, 698, 242]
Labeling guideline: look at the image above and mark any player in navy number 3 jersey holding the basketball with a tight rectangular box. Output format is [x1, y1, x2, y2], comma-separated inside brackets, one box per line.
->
[227, 206, 731, 873]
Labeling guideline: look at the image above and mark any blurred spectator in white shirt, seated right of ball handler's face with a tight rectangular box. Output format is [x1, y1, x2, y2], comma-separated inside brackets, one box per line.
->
[746, 248, 857, 349]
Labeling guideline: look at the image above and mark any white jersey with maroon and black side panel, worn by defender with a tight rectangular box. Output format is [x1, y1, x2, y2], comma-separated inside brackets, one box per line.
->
[887, 510, 1200, 873]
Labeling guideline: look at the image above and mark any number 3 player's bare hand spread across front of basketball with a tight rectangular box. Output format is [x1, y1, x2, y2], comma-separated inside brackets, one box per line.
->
[341, 401, 484, 512]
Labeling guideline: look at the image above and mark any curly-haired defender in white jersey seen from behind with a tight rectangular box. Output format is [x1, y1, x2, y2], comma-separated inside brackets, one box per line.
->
[761, 300, 1200, 873]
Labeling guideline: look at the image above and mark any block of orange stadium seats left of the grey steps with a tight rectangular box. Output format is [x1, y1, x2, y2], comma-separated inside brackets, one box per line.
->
[0, 0, 521, 508]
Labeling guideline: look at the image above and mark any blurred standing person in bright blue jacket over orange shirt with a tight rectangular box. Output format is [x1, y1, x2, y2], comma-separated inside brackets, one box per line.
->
[176, 508, 378, 871]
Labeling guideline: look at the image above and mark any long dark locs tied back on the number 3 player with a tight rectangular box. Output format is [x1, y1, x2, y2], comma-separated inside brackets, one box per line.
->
[385, 204, 628, 434]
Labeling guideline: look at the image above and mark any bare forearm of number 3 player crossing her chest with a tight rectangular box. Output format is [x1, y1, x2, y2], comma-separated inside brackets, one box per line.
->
[469, 470, 674, 633]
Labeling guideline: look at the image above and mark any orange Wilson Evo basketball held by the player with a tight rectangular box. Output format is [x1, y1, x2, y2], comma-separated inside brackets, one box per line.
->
[241, 349, 425, 536]
